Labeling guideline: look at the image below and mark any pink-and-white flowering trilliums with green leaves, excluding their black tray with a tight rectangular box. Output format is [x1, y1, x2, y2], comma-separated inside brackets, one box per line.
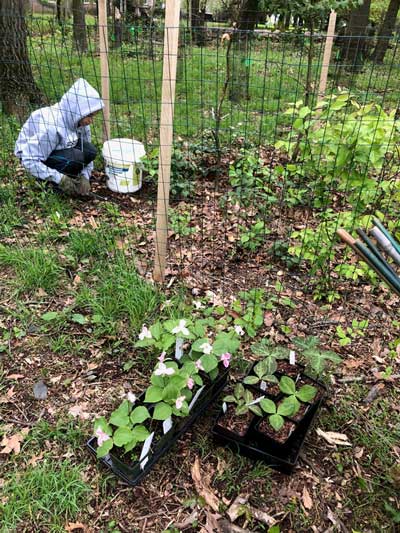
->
[94, 318, 240, 457]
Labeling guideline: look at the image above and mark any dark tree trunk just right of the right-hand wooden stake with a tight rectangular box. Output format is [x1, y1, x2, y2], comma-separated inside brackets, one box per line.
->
[340, 0, 371, 72]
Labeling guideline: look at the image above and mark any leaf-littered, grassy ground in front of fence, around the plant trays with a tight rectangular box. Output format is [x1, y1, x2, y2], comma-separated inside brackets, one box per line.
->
[0, 164, 400, 533]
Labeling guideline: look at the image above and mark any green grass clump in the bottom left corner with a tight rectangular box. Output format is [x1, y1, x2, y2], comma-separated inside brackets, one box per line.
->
[0, 460, 90, 533]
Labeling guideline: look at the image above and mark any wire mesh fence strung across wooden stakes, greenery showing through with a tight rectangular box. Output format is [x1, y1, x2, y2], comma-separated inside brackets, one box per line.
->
[1, 8, 400, 316]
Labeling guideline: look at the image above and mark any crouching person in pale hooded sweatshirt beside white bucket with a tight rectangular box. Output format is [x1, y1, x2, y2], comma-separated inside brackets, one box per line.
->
[14, 79, 104, 196]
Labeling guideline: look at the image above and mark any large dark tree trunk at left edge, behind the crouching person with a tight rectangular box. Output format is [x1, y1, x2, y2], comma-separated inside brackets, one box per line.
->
[0, 0, 44, 119]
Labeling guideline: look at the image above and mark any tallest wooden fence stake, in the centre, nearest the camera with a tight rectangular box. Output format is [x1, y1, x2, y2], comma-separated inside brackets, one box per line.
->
[153, 0, 180, 282]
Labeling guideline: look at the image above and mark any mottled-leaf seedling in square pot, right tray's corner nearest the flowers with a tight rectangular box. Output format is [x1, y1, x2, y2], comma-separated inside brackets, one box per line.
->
[217, 383, 262, 440]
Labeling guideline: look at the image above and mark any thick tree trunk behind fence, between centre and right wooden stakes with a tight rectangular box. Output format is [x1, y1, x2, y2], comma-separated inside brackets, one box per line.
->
[229, 0, 258, 102]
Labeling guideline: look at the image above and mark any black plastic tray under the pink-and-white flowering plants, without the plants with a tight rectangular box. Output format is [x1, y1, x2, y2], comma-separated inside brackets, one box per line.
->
[86, 369, 228, 487]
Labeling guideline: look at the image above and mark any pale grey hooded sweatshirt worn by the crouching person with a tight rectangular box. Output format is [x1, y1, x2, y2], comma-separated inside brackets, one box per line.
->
[14, 78, 104, 183]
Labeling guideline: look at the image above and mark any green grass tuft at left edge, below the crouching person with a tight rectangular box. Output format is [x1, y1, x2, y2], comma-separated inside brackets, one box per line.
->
[0, 244, 62, 293]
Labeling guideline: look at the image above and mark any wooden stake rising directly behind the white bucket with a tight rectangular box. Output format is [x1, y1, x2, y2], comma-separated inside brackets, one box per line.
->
[98, 0, 110, 141]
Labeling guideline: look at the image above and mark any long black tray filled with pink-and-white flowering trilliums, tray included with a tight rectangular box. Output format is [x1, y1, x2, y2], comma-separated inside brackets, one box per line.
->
[88, 319, 239, 485]
